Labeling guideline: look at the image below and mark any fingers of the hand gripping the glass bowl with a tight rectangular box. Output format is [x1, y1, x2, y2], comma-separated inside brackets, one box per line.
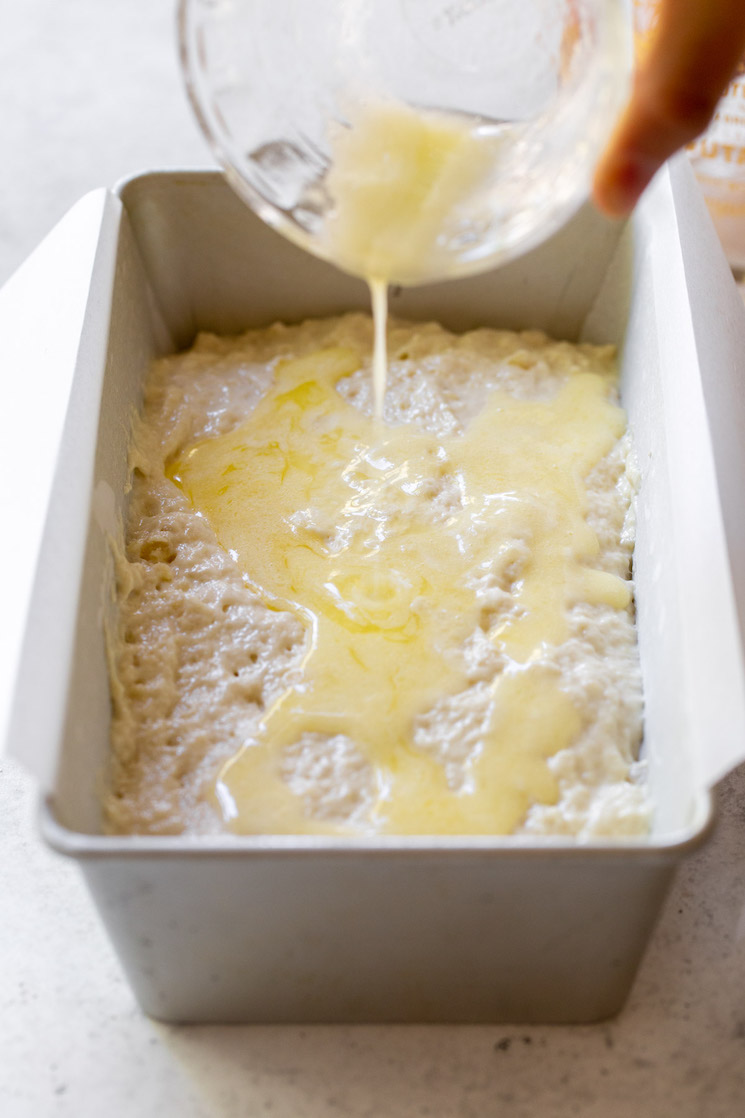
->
[593, 0, 745, 217]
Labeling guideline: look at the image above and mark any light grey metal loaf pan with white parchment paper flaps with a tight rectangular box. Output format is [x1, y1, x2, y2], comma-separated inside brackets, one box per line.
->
[11, 165, 745, 1022]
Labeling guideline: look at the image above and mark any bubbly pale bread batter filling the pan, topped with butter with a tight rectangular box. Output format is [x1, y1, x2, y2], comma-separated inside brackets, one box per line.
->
[105, 315, 649, 839]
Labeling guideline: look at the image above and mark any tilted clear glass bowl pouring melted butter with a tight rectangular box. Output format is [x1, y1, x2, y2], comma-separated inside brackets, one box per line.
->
[179, 0, 631, 284]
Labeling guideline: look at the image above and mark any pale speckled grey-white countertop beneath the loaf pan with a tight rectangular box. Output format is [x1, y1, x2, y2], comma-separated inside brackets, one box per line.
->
[0, 0, 745, 1118]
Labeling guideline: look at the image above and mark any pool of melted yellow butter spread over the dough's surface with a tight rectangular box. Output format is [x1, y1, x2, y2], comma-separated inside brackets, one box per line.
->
[171, 349, 629, 834]
